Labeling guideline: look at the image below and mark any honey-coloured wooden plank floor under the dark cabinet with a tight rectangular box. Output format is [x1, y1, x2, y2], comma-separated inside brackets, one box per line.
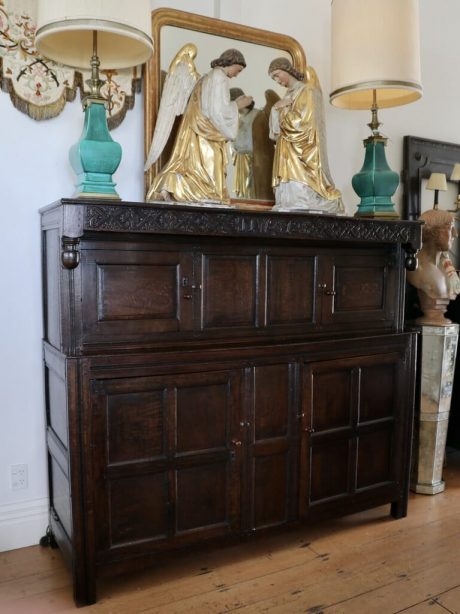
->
[0, 452, 460, 614]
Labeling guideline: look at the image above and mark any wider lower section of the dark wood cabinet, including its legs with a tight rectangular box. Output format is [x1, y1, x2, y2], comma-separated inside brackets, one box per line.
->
[45, 334, 415, 604]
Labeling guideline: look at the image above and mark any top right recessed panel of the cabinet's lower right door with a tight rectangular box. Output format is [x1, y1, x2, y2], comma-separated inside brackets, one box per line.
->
[359, 363, 396, 423]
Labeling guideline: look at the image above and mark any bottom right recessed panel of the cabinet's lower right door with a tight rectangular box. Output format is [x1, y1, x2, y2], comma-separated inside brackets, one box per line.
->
[357, 429, 392, 488]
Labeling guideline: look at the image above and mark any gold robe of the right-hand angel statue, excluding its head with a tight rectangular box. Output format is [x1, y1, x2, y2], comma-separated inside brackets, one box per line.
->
[270, 81, 340, 212]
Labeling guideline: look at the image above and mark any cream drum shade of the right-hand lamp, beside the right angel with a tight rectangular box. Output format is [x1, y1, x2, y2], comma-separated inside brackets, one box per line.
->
[330, 0, 422, 109]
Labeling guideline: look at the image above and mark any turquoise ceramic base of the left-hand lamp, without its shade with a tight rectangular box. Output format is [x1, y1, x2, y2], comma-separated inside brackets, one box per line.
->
[69, 97, 121, 199]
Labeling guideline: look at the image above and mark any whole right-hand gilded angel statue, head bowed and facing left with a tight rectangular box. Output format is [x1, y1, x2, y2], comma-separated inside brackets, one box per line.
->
[268, 57, 343, 213]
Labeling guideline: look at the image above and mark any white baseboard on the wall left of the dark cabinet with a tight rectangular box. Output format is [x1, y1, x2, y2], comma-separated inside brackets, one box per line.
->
[0, 498, 49, 552]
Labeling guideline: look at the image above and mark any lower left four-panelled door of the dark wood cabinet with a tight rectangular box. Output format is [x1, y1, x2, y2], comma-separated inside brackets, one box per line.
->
[92, 371, 241, 558]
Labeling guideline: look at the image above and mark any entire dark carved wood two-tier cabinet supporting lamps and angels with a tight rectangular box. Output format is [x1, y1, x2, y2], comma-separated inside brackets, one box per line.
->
[41, 200, 421, 605]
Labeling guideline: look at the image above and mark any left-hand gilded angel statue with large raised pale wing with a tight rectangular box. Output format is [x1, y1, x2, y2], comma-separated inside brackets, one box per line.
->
[145, 43, 252, 203]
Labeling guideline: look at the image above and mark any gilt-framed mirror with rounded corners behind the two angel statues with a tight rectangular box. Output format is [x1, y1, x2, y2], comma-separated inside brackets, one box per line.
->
[144, 9, 306, 207]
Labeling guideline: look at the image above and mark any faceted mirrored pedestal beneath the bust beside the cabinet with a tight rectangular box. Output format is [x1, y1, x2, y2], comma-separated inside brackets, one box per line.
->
[411, 324, 459, 495]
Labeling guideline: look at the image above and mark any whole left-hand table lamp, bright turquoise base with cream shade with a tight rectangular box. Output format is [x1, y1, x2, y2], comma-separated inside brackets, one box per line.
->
[35, 0, 153, 199]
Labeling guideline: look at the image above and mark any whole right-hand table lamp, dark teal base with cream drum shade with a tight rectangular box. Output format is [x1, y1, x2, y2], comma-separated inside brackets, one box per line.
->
[330, 0, 422, 218]
